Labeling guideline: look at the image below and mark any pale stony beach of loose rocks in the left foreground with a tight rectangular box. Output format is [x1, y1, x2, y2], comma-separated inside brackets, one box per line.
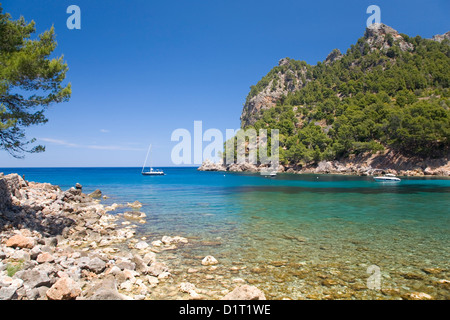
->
[0, 174, 265, 300]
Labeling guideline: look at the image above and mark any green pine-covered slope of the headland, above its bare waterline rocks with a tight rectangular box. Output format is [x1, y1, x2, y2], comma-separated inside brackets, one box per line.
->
[241, 25, 450, 164]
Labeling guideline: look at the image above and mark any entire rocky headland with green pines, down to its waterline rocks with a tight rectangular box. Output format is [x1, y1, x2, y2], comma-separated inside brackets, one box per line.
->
[221, 23, 450, 177]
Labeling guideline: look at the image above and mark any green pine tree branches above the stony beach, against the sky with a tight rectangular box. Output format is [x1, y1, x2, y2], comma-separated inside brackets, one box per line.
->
[0, 7, 71, 158]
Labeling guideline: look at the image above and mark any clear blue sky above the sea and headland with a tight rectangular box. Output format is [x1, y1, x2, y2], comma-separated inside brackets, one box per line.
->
[0, 0, 450, 167]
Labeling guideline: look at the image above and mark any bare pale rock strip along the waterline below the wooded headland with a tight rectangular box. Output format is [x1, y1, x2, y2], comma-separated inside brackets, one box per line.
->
[198, 151, 450, 177]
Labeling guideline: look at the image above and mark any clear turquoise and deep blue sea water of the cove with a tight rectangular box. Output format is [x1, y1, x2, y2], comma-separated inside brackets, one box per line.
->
[0, 168, 450, 299]
